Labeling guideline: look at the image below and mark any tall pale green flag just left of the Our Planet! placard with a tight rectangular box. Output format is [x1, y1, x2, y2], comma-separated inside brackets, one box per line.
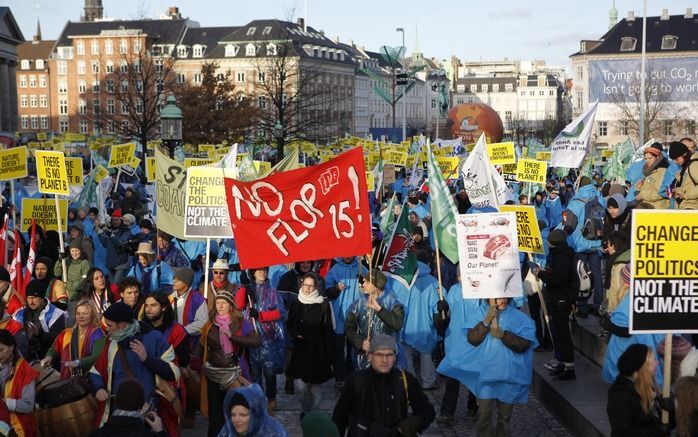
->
[427, 145, 458, 264]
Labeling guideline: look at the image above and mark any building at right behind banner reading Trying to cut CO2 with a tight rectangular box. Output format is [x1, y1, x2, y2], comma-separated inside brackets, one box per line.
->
[570, 8, 698, 146]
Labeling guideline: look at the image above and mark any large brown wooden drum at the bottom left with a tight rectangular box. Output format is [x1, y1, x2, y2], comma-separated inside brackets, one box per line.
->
[36, 377, 97, 437]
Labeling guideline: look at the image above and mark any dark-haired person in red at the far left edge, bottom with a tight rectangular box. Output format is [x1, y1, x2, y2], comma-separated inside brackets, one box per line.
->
[0, 329, 39, 437]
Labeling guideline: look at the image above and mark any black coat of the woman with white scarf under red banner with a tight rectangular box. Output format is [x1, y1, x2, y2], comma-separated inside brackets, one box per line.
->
[286, 299, 335, 384]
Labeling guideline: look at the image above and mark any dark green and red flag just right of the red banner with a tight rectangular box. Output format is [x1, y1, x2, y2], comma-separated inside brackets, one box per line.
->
[381, 204, 417, 289]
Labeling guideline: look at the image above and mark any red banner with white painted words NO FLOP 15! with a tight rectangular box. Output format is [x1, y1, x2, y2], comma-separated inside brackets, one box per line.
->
[225, 147, 371, 269]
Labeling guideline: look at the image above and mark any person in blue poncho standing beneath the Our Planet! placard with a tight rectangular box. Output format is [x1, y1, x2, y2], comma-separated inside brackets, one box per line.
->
[461, 298, 538, 437]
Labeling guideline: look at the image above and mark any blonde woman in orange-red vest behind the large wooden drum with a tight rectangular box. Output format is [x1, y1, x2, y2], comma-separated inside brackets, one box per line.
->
[41, 299, 105, 379]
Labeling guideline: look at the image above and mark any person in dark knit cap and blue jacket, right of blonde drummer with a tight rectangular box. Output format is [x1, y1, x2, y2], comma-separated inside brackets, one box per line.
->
[89, 302, 180, 426]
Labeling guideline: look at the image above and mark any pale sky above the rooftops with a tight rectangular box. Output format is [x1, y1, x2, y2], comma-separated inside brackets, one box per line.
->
[5, 0, 698, 71]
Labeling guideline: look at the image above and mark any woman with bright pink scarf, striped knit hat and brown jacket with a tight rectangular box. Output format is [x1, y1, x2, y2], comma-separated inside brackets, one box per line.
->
[196, 290, 262, 437]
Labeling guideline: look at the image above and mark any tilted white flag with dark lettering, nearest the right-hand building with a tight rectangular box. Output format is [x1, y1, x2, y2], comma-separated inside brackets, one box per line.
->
[550, 101, 599, 168]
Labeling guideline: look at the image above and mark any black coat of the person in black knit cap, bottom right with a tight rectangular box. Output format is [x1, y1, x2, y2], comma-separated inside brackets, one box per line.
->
[606, 375, 662, 437]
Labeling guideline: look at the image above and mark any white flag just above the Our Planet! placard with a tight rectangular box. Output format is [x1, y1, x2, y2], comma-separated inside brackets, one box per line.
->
[461, 134, 498, 209]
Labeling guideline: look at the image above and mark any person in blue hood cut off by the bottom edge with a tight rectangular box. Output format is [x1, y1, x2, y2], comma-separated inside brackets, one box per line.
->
[218, 384, 288, 437]
